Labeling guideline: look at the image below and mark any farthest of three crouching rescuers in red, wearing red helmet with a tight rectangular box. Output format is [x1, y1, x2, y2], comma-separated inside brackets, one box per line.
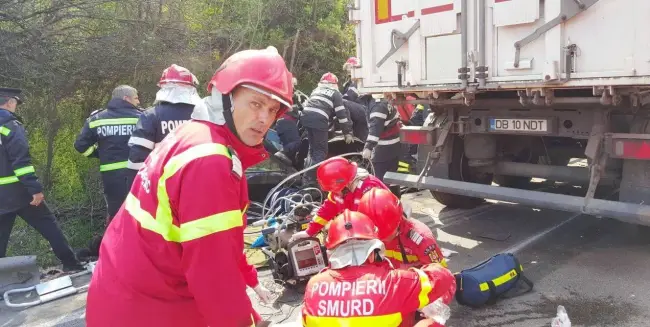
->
[289, 157, 388, 242]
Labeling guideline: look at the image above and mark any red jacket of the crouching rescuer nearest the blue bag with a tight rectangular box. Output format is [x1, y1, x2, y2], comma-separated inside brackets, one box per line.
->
[384, 218, 447, 268]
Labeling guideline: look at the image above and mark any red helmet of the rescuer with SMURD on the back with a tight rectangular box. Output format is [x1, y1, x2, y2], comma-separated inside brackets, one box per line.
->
[325, 209, 377, 250]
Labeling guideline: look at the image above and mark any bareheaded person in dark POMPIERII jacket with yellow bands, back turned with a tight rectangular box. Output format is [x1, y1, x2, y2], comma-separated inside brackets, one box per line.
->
[74, 85, 142, 221]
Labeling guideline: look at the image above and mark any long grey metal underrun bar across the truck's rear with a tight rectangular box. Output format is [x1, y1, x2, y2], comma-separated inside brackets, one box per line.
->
[384, 172, 650, 226]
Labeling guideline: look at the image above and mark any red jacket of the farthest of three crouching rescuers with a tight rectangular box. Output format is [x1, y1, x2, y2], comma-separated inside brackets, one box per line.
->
[307, 175, 388, 236]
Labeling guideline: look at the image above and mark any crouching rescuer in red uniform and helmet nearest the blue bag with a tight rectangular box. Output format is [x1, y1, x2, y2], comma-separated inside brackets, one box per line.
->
[357, 189, 447, 268]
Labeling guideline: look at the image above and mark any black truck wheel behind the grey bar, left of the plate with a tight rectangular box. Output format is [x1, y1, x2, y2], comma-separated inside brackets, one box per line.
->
[431, 136, 492, 209]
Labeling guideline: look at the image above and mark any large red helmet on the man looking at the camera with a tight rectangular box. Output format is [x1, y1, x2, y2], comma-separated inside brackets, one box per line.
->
[208, 47, 293, 117]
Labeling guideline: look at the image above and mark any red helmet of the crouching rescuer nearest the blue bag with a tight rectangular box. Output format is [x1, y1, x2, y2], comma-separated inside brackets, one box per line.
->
[357, 188, 404, 240]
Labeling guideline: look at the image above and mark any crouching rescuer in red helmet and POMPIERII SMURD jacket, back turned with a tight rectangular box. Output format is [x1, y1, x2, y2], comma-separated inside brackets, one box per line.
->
[302, 210, 456, 327]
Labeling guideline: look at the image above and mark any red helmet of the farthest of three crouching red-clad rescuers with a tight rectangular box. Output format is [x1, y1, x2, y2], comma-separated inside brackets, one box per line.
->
[316, 157, 357, 193]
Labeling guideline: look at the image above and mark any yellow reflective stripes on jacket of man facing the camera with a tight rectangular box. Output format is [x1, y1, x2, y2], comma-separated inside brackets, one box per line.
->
[125, 143, 244, 242]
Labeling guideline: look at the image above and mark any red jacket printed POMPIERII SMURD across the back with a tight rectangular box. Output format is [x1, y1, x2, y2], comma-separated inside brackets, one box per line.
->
[302, 262, 456, 327]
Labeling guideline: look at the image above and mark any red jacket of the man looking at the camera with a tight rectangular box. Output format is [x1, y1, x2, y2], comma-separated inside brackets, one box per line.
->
[86, 120, 268, 327]
